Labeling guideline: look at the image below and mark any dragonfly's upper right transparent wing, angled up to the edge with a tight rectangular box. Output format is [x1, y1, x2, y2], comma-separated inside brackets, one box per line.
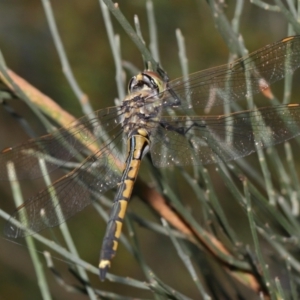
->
[163, 36, 300, 108]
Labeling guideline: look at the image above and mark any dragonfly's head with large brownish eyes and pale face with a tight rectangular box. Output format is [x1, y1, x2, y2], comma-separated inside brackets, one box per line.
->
[128, 71, 165, 94]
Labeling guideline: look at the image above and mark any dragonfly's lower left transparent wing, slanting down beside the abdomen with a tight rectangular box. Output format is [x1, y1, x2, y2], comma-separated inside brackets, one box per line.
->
[4, 125, 125, 238]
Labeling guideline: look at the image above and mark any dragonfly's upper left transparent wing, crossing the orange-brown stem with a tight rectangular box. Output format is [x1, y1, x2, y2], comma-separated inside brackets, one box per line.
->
[0, 107, 122, 180]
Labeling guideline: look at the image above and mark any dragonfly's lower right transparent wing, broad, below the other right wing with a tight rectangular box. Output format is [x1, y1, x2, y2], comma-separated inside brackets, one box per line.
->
[150, 105, 300, 167]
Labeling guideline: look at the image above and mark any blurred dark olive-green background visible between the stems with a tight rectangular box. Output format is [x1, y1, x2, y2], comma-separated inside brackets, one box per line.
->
[0, 0, 296, 299]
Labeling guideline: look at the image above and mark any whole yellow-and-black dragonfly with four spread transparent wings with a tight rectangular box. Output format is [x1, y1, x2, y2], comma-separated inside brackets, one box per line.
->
[0, 36, 300, 280]
